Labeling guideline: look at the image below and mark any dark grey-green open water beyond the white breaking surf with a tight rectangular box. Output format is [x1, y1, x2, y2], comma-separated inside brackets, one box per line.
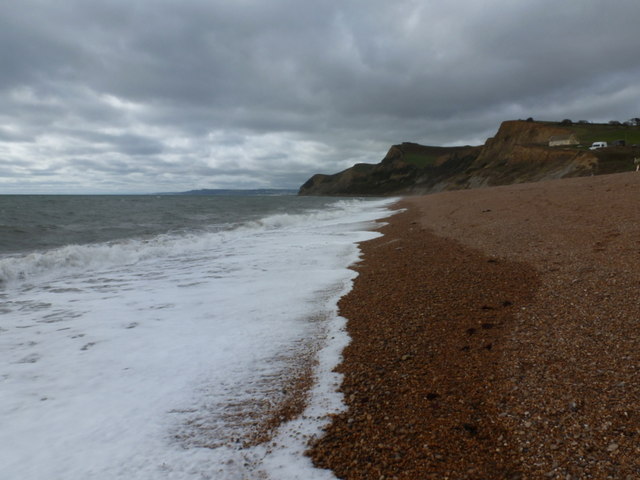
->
[0, 195, 350, 254]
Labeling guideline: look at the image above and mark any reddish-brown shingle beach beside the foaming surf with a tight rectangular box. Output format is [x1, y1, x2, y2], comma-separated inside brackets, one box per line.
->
[309, 172, 640, 480]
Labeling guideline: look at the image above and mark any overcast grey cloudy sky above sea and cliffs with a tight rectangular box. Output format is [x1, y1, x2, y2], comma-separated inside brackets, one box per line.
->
[0, 0, 640, 194]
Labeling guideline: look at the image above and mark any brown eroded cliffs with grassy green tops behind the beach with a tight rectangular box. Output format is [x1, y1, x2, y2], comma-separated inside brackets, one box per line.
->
[298, 120, 640, 196]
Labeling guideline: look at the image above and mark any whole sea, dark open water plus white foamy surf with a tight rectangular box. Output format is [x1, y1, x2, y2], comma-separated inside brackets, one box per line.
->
[0, 195, 394, 480]
